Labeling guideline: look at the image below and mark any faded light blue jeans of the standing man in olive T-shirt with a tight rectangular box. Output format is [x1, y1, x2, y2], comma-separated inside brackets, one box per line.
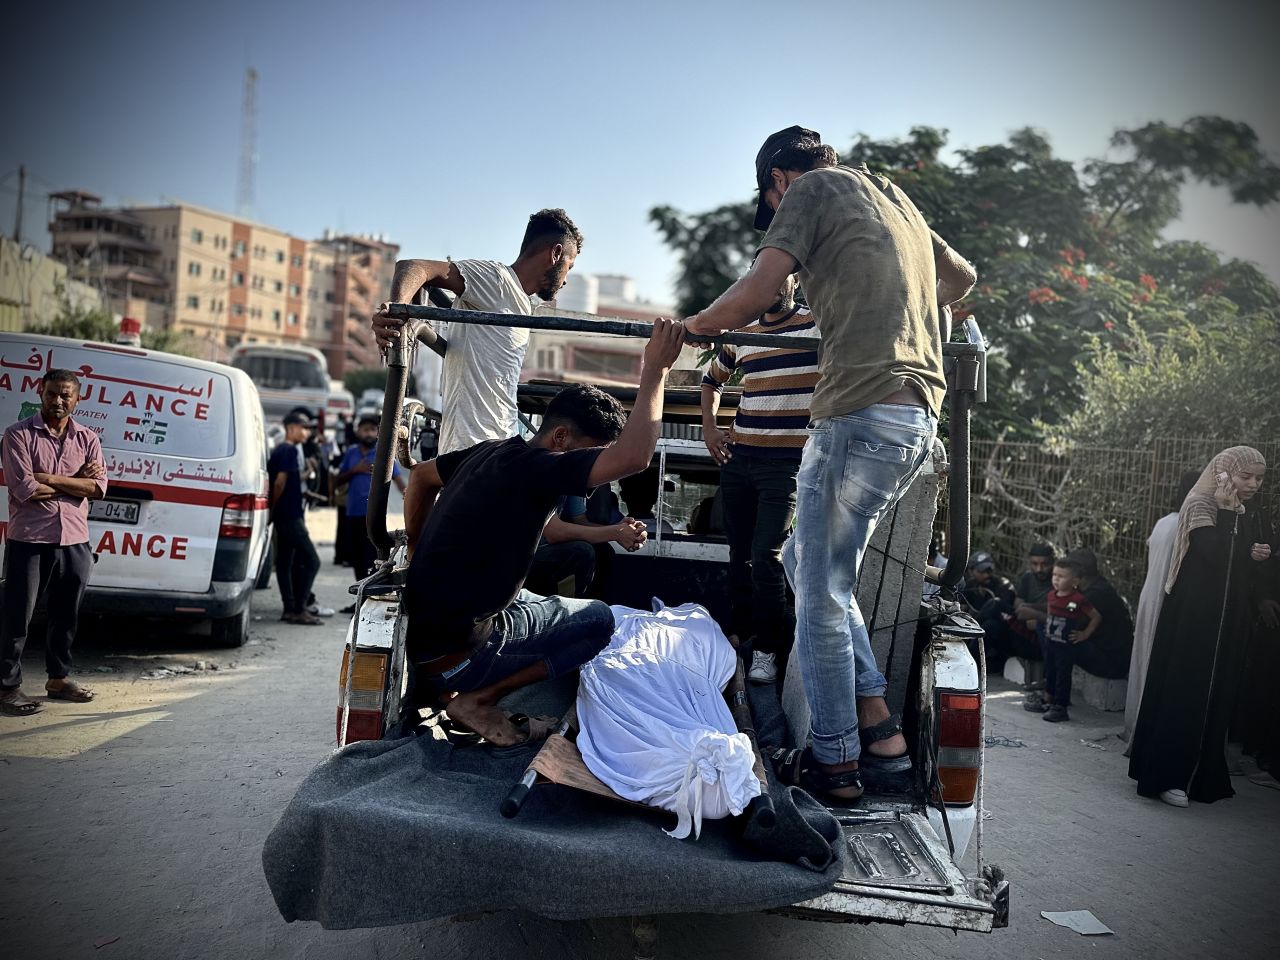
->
[782, 403, 937, 764]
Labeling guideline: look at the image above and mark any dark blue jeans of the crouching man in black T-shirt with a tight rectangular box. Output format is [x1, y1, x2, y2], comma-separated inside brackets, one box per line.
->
[434, 590, 613, 692]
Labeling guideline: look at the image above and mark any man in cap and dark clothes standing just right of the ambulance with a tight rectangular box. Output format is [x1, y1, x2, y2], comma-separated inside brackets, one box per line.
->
[266, 410, 324, 626]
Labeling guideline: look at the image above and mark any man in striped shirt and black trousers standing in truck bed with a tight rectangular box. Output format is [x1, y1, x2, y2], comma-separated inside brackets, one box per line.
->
[701, 276, 818, 684]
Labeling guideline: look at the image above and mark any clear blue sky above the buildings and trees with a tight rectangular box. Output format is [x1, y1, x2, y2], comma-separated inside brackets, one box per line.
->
[0, 0, 1280, 303]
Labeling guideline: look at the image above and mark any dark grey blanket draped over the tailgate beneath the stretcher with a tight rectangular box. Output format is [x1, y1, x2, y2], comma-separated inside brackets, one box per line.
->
[262, 680, 842, 929]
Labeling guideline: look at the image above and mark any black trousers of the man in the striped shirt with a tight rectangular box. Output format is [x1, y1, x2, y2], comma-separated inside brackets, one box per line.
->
[721, 447, 800, 662]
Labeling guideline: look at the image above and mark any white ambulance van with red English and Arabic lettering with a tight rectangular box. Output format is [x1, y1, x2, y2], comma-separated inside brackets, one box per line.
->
[0, 333, 270, 646]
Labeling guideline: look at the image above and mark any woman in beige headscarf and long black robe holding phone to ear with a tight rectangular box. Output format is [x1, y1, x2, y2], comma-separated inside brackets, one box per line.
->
[1129, 447, 1271, 806]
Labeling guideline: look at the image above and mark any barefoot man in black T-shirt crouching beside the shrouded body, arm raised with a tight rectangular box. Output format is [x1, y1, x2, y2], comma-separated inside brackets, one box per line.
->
[404, 320, 684, 746]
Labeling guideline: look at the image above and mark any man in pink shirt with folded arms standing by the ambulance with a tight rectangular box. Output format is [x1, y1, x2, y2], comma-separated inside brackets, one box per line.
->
[0, 370, 106, 717]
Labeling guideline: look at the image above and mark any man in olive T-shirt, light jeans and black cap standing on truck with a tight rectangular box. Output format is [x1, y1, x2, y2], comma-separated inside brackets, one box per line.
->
[685, 127, 975, 801]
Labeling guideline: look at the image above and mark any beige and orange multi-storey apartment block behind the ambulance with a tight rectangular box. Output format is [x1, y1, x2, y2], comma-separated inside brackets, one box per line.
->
[50, 191, 398, 379]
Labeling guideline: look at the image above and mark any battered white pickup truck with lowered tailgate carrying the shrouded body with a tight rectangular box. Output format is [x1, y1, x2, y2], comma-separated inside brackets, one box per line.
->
[312, 313, 1009, 936]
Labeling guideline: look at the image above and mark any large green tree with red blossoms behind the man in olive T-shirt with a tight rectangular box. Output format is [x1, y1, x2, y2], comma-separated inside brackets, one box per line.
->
[650, 116, 1280, 439]
